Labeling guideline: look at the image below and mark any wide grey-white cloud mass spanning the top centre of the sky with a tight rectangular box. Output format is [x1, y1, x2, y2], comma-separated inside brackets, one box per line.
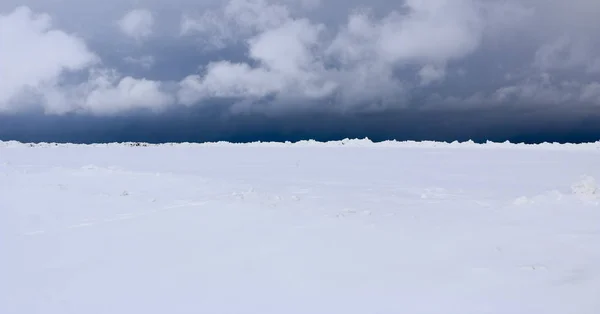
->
[180, 0, 492, 110]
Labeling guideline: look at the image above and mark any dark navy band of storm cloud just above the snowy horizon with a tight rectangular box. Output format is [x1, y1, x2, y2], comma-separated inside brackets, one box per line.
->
[0, 106, 600, 143]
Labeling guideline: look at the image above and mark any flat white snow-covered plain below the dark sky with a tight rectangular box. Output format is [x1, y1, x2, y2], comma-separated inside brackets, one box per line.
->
[0, 141, 600, 314]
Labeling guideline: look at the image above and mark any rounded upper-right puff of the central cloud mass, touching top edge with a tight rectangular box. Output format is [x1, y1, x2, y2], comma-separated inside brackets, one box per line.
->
[328, 0, 483, 64]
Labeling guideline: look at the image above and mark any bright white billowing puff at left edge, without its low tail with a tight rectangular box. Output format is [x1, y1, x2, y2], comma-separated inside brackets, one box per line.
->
[0, 7, 98, 111]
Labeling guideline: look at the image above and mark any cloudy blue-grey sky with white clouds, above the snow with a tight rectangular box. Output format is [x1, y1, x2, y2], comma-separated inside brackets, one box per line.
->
[0, 0, 600, 139]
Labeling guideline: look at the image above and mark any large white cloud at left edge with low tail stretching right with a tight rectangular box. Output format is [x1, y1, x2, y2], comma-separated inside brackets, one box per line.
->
[0, 7, 174, 114]
